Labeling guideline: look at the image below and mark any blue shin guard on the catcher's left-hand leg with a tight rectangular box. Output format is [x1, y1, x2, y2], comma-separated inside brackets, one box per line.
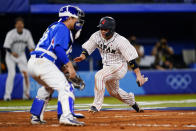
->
[30, 98, 45, 117]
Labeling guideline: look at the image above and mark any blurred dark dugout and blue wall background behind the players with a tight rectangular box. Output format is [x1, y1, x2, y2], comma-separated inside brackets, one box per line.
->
[0, 0, 196, 99]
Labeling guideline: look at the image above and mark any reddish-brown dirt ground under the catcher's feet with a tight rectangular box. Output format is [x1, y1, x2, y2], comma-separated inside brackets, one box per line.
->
[0, 110, 196, 131]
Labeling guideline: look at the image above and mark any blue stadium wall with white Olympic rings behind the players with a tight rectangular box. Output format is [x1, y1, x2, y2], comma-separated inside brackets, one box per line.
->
[0, 70, 196, 99]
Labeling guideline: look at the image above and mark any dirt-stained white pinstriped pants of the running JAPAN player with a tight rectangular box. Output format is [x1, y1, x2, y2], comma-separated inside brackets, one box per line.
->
[93, 63, 135, 110]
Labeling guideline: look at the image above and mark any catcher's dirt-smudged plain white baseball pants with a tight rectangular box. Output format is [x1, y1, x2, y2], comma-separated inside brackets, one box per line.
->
[28, 55, 74, 115]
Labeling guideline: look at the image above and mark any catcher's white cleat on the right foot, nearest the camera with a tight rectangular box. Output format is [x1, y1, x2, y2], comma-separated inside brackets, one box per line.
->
[59, 114, 85, 126]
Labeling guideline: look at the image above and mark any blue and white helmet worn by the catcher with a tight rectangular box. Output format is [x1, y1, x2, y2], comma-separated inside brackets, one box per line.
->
[59, 5, 84, 30]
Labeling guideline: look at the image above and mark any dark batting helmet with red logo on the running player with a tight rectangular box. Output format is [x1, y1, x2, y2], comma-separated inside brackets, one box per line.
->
[97, 16, 116, 37]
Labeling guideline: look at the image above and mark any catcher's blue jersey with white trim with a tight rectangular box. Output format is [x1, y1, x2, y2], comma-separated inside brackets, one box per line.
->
[31, 22, 71, 67]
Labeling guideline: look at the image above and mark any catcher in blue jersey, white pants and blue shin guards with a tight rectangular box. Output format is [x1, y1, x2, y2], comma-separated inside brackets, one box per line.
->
[28, 5, 84, 126]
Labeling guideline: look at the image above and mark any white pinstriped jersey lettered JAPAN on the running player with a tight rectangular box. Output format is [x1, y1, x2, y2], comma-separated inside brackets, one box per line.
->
[82, 31, 138, 65]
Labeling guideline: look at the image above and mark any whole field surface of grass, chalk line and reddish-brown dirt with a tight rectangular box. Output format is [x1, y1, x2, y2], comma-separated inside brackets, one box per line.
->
[0, 94, 196, 131]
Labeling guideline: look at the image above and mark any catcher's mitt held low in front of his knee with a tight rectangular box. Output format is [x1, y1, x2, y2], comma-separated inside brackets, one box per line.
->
[65, 73, 85, 90]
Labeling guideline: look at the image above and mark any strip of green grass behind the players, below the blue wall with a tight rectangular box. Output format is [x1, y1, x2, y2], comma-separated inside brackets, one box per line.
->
[0, 94, 196, 111]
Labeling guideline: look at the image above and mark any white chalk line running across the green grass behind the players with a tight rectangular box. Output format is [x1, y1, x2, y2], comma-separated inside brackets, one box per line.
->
[0, 99, 196, 110]
